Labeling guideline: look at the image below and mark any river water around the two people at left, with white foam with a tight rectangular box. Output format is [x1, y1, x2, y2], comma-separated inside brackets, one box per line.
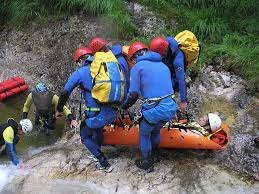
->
[0, 94, 64, 191]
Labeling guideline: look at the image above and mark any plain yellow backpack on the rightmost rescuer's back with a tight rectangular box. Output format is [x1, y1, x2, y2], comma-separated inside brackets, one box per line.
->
[175, 30, 200, 67]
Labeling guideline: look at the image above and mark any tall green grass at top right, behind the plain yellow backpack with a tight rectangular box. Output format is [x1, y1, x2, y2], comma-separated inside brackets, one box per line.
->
[137, 0, 259, 89]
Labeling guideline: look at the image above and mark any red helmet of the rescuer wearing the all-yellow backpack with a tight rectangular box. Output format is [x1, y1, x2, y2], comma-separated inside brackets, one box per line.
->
[150, 36, 169, 56]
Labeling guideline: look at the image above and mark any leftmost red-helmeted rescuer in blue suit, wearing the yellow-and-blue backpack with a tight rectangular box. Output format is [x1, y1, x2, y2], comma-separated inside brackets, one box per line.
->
[56, 46, 117, 172]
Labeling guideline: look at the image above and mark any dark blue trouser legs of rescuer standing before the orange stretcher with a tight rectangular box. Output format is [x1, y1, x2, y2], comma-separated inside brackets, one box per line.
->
[139, 118, 166, 159]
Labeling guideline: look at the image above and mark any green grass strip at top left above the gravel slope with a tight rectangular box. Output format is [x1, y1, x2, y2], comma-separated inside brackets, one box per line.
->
[0, 0, 135, 38]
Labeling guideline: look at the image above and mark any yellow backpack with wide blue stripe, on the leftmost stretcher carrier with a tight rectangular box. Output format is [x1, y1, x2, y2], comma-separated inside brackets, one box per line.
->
[90, 51, 126, 105]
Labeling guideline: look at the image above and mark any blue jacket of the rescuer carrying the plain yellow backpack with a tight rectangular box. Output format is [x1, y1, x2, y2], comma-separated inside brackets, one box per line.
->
[167, 36, 187, 102]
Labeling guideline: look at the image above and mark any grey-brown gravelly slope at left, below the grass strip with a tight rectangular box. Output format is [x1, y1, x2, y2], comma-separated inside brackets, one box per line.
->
[0, 14, 107, 90]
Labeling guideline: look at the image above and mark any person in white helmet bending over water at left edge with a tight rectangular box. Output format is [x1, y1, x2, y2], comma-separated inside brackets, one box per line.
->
[0, 118, 33, 166]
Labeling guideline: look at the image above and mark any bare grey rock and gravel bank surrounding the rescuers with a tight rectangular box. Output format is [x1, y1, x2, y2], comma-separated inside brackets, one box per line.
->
[0, 3, 259, 193]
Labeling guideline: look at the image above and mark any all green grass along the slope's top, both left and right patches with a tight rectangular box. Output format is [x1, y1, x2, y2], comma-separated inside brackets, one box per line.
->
[0, 0, 259, 87]
